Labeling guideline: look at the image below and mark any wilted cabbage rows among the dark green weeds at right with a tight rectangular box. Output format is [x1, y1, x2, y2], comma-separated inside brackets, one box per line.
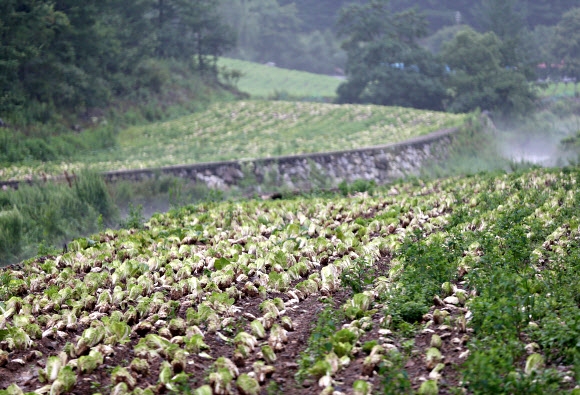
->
[276, 171, 580, 395]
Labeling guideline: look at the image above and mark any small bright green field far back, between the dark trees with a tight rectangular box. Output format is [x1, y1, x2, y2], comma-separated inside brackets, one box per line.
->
[218, 58, 342, 98]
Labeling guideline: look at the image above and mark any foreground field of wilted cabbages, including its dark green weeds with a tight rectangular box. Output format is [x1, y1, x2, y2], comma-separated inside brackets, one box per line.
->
[0, 168, 580, 395]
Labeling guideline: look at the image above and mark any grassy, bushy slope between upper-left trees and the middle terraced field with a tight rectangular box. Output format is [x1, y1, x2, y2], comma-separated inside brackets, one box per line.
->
[0, 61, 240, 180]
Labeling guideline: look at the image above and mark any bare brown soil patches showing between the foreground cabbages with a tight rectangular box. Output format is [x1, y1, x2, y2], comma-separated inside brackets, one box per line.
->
[0, 188, 464, 395]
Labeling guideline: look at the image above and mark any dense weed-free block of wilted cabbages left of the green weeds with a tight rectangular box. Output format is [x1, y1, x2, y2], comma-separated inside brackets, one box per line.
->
[0, 181, 453, 393]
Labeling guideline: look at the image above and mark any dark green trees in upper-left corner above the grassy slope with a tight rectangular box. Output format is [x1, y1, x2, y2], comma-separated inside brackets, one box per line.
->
[0, 0, 235, 120]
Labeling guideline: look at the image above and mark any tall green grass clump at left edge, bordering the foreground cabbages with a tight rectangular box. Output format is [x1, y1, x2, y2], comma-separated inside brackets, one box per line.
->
[0, 172, 117, 265]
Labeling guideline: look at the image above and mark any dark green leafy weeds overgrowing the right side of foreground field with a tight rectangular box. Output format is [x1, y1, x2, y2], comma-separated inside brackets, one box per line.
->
[374, 168, 580, 394]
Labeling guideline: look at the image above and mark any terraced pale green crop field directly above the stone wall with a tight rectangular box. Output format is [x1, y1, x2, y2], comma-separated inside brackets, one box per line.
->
[0, 101, 464, 179]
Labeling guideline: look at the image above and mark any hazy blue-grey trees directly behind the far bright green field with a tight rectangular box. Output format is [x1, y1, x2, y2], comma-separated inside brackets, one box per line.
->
[221, 0, 344, 74]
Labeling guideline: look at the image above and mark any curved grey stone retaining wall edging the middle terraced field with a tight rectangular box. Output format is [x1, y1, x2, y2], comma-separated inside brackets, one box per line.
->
[0, 129, 457, 190]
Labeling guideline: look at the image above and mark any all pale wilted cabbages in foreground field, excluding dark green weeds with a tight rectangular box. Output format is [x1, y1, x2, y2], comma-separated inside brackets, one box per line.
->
[0, 171, 578, 394]
